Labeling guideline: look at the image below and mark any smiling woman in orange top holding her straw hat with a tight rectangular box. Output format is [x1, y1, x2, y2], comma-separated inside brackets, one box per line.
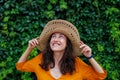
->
[16, 20, 106, 80]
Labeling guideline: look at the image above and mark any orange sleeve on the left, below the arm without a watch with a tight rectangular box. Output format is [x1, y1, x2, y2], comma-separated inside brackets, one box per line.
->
[16, 54, 41, 72]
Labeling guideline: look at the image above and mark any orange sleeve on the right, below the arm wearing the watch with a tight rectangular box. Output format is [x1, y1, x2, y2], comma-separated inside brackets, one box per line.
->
[76, 58, 107, 80]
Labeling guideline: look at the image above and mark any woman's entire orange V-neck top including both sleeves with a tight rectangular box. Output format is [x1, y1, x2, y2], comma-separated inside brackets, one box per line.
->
[16, 53, 107, 80]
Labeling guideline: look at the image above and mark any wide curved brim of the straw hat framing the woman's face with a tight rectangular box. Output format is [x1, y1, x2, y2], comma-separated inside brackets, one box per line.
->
[37, 19, 80, 55]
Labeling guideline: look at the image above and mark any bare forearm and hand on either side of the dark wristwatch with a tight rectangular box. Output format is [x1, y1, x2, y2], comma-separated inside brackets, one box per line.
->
[80, 41, 104, 73]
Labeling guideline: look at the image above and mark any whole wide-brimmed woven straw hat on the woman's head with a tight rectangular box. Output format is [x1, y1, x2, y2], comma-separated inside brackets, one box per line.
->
[37, 19, 80, 55]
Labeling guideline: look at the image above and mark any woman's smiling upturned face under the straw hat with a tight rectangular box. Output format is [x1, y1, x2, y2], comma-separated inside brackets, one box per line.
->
[50, 33, 67, 52]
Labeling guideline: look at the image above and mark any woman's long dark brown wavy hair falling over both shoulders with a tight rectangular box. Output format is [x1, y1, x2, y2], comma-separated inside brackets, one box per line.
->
[40, 37, 75, 74]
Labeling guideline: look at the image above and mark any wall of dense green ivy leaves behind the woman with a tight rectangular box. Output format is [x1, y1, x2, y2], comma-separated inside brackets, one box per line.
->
[0, 0, 120, 80]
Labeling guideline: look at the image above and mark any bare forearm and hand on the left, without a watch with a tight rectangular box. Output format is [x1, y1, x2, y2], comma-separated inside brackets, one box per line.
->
[18, 39, 38, 63]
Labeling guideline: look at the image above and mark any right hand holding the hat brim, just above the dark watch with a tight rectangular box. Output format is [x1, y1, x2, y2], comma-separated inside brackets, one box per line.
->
[80, 41, 92, 57]
